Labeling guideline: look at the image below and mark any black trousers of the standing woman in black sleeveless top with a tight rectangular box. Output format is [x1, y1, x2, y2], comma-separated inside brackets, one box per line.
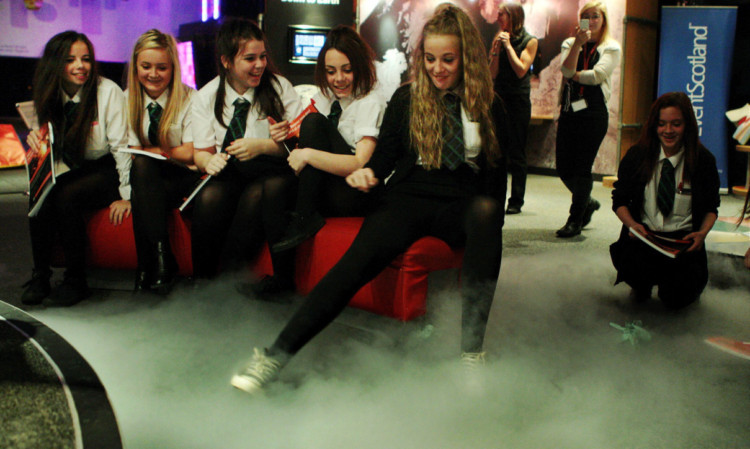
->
[503, 95, 531, 207]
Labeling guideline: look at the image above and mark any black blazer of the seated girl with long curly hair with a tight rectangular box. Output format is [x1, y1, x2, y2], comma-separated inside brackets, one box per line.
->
[365, 84, 508, 203]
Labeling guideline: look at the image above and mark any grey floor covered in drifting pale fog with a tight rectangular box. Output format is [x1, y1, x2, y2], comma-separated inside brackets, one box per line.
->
[0, 175, 750, 449]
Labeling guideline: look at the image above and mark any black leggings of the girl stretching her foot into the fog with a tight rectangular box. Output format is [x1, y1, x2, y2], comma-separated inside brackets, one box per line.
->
[269, 188, 504, 355]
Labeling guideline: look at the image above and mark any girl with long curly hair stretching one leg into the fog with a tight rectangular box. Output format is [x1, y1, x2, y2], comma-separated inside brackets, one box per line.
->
[231, 4, 505, 393]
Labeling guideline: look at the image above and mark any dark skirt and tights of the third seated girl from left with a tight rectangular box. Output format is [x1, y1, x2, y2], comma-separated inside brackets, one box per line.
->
[191, 156, 296, 278]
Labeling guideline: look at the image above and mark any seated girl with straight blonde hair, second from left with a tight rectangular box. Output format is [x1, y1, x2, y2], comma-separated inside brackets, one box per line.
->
[127, 30, 200, 294]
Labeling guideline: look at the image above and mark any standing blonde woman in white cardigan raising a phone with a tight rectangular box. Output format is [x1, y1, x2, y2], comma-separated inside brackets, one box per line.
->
[555, 0, 621, 238]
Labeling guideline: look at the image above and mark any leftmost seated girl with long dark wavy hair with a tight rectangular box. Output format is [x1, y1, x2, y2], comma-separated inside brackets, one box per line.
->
[21, 31, 130, 305]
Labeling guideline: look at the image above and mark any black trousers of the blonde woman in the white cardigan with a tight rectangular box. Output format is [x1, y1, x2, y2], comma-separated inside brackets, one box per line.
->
[555, 109, 609, 222]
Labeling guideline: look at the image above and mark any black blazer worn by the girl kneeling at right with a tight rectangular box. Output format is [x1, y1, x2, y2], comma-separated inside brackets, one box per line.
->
[612, 145, 720, 235]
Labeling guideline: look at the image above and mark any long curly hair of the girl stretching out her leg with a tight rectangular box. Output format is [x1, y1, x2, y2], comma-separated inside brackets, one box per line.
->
[409, 3, 500, 169]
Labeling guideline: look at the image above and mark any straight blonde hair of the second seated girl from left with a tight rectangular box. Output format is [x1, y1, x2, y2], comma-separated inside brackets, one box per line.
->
[128, 29, 190, 148]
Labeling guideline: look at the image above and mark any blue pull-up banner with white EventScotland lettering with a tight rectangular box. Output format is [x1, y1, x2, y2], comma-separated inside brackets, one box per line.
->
[658, 6, 737, 190]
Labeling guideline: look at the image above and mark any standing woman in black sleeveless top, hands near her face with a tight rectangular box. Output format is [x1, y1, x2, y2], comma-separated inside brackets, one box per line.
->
[490, 3, 539, 214]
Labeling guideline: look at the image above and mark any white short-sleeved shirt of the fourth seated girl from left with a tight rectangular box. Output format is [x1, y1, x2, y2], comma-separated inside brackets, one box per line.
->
[313, 90, 385, 153]
